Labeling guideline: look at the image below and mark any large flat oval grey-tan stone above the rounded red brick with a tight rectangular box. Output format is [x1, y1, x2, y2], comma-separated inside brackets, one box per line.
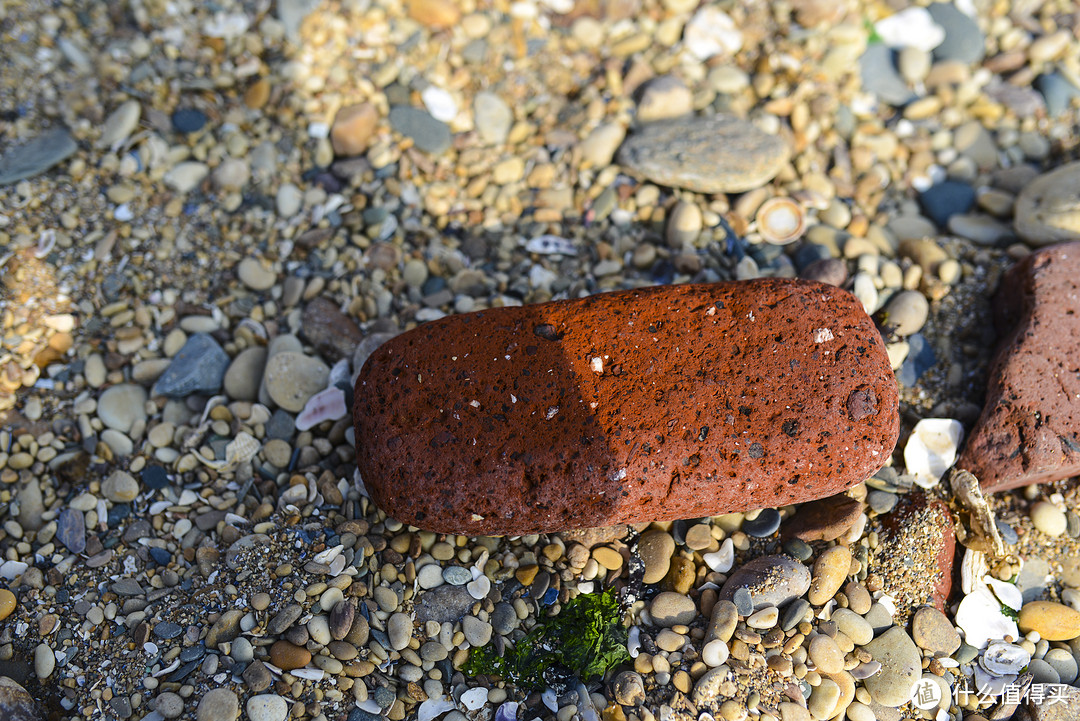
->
[619, 115, 791, 193]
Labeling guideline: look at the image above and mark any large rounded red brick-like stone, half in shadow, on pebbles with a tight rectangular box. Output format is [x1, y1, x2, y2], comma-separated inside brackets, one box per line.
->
[353, 278, 900, 535]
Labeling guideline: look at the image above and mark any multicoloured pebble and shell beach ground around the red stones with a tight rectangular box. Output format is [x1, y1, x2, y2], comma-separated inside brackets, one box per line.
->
[0, 0, 1080, 721]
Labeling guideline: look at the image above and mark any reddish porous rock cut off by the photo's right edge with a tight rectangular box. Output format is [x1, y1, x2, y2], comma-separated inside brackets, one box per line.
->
[957, 243, 1080, 491]
